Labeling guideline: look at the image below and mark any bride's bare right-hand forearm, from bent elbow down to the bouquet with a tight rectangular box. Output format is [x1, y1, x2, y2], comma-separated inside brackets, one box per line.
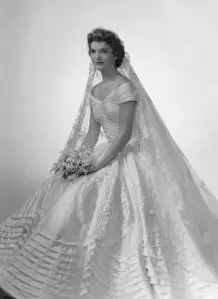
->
[96, 133, 130, 169]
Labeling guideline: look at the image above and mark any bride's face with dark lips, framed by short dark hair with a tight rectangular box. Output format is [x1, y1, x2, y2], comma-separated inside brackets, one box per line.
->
[90, 41, 115, 71]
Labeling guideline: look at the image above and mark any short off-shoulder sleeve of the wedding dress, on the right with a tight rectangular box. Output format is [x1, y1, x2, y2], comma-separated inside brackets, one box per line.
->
[115, 83, 138, 104]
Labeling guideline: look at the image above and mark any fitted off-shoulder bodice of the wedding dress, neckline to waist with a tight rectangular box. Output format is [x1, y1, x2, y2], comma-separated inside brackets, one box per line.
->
[90, 82, 137, 142]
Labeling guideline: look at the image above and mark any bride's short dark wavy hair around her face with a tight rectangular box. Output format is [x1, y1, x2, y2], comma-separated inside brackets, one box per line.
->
[87, 27, 125, 68]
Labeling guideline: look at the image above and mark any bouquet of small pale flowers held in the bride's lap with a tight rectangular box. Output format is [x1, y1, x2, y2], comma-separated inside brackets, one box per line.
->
[50, 146, 92, 181]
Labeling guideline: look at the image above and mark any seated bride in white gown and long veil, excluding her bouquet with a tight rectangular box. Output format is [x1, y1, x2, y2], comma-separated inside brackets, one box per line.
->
[0, 28, 218, 299]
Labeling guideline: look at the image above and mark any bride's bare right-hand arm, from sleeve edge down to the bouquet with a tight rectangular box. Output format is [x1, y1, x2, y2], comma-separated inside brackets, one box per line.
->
[90, 101, 136, 172]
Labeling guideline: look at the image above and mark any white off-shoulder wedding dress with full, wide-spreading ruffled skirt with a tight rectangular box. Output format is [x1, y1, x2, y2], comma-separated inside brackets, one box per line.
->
[0, 83, 218, 299]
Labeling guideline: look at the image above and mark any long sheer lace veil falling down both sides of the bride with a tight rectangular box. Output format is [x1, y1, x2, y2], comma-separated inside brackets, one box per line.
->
[56, 53, 218, 280]
